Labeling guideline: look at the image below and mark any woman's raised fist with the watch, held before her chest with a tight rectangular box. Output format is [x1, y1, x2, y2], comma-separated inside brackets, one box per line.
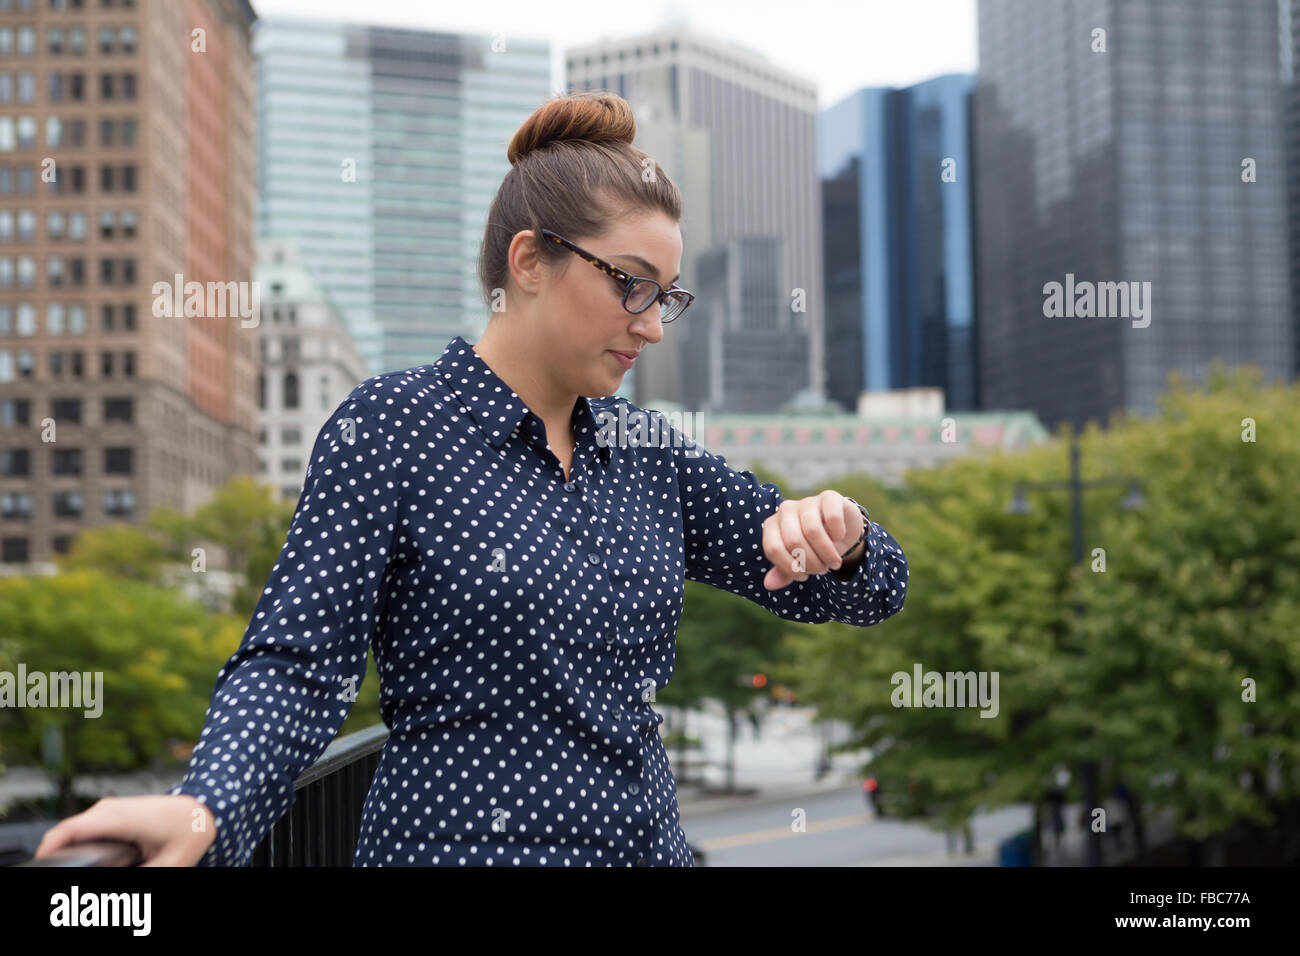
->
[763, 489, 862, 591]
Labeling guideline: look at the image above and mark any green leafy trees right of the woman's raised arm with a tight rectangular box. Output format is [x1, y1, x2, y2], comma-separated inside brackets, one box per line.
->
[780, 371, 1300, 868]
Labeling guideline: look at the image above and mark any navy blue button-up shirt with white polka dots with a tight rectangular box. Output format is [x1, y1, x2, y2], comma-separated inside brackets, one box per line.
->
[169, 336, 907, 866]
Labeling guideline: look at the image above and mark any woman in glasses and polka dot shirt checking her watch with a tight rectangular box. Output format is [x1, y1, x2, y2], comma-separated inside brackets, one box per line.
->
[30, 94, 907, 866]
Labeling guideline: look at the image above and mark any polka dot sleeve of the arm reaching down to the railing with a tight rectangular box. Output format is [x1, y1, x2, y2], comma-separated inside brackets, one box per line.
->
[168, 382, 398, 866]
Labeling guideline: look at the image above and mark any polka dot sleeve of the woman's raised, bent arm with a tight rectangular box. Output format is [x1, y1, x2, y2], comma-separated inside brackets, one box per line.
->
[671, 418, 907, 627]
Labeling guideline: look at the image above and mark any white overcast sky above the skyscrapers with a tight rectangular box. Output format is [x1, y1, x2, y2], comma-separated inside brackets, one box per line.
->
[251, 0, 976, 108]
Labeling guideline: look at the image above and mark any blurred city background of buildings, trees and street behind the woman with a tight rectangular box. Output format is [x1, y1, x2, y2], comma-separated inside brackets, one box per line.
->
[0, 0, 1300, 866]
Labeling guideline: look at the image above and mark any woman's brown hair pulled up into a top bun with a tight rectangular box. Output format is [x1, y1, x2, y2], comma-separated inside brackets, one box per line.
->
[478, 91, 681, 307]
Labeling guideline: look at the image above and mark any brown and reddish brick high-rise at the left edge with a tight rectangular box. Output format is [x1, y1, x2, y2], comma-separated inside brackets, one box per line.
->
[0, 0, 257, 563]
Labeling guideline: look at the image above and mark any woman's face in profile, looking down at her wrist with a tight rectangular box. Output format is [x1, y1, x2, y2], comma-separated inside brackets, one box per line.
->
[520, 212, 681, 397]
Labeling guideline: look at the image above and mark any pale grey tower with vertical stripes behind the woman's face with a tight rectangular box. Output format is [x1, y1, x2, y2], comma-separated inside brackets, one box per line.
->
[566, 26, 826, 411]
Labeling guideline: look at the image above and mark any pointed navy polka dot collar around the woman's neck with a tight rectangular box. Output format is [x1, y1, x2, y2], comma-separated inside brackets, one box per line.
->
[433, 336, 611, 464]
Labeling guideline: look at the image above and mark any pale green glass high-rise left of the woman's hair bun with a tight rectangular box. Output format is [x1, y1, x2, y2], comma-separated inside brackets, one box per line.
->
[254, 18, 551, 373]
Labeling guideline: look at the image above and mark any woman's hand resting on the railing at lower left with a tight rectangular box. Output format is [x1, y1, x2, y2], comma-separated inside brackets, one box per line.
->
[36, 793, 217, 866]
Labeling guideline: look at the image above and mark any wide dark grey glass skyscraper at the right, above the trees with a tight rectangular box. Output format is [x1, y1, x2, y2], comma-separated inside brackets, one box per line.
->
[974, 0, 1294, 427]
